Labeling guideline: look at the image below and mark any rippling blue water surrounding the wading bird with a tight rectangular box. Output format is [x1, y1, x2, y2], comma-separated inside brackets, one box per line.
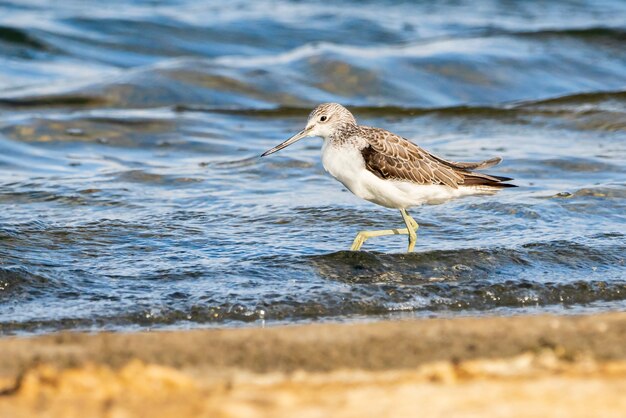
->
[0, 0, 626, 335]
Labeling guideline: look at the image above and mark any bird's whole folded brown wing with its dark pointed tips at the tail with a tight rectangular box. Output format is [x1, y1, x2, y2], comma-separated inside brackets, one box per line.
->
[360, 127, 511, 188]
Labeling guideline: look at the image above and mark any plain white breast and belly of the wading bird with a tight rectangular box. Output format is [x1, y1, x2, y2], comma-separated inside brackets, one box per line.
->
[322, 141, 490, 209]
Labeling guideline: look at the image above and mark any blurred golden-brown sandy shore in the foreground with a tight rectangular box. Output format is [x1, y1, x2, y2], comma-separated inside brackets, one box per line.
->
[0, 313, 626, 417]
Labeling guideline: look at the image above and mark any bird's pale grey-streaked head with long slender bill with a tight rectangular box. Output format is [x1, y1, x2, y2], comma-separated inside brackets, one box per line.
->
[261, 103, 356, 157]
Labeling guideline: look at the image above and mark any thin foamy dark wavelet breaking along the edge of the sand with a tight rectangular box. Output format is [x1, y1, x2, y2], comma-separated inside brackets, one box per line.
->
[0, 280, 626, 335]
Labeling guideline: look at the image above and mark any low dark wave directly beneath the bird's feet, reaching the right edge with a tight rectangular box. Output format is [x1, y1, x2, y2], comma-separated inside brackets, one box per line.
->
[310, 241, 626, 285]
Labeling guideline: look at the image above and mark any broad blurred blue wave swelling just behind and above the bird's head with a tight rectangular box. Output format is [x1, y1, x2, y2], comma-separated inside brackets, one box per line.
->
[0, 30, 623, 112]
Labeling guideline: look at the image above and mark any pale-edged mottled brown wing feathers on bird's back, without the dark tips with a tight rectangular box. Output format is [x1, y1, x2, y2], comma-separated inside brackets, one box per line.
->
[360, 127, 464, 188]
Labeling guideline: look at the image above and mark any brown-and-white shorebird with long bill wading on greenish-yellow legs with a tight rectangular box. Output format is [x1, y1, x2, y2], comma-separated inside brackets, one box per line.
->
[261, 103, 516, 252]
